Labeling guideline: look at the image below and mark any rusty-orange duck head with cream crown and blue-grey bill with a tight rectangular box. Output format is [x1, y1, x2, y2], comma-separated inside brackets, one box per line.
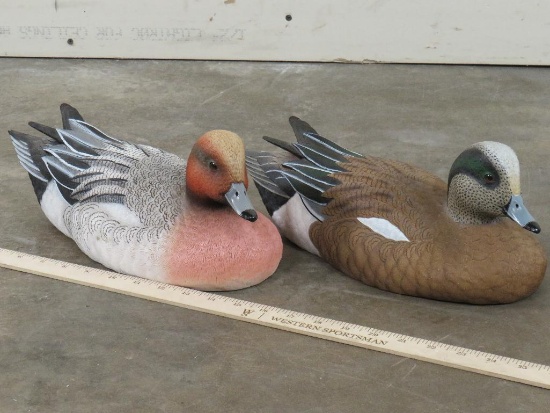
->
[186, 130, 258, 222]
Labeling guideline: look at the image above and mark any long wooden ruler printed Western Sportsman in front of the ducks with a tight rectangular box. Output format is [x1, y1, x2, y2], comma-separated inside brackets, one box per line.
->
[0, 248, 550, 389]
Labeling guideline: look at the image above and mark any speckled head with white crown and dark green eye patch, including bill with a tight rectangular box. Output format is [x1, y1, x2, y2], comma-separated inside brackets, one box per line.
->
[448, 141, 540, 233]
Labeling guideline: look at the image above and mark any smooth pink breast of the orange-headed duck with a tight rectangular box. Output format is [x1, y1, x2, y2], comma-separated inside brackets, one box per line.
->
[164, 207, 283, 291]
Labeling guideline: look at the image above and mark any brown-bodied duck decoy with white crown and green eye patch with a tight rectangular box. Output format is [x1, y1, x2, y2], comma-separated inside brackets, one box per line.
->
[247, 117, 546, 304]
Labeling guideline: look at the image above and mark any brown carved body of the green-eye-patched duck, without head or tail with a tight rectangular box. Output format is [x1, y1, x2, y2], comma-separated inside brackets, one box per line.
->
[310, 157, 547, 304]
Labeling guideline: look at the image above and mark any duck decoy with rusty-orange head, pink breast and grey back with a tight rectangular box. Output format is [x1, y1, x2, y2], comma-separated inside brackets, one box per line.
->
[10, 104, 282, 290]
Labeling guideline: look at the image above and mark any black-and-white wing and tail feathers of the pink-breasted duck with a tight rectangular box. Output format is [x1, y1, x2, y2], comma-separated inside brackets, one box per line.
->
[10, 103, 152, 204]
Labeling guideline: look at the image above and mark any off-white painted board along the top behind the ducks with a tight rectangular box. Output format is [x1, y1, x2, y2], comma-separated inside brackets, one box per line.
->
[0, 0, 550, 65]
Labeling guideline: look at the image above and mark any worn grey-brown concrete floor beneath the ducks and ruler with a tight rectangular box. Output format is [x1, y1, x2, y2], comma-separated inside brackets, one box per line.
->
[0, 59, 550, 413]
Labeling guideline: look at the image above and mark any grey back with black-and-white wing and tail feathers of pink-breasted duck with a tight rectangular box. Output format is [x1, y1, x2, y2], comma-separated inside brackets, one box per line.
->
[10, 104, 185, 226]
